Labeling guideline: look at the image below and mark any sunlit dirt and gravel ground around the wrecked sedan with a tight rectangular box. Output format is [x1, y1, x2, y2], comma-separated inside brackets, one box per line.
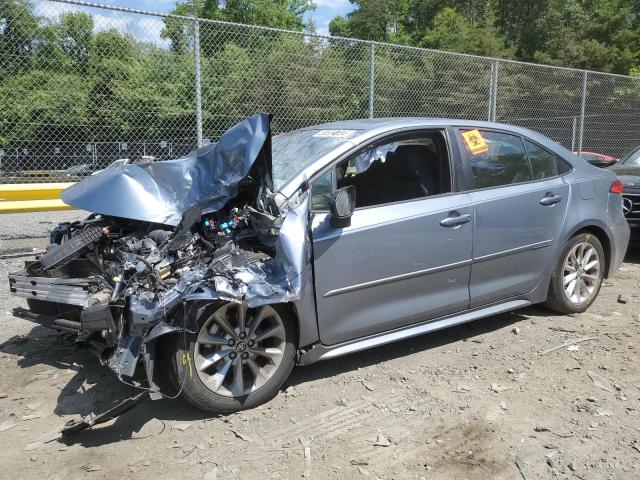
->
[0, 214, 640, 480]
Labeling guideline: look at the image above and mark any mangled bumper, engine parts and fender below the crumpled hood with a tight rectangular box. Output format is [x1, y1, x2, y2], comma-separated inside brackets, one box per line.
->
[9, 189, 309, 399]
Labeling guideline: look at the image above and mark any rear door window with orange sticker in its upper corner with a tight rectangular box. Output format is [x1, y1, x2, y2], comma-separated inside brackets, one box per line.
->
[462, 130, 532, 188]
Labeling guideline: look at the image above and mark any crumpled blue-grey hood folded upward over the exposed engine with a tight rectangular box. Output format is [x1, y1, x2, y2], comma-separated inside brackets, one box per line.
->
[61, 113, 272, 226]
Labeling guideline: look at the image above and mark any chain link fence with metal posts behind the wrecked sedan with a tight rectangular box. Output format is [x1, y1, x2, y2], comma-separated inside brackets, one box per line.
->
[0, 0, 640, 183]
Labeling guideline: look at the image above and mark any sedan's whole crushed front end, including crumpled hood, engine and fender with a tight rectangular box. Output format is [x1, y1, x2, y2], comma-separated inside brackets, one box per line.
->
[9, 114, 309, 398]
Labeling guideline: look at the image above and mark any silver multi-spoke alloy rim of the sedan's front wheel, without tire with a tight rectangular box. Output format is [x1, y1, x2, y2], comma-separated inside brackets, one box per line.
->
[193, 303, 286, 397]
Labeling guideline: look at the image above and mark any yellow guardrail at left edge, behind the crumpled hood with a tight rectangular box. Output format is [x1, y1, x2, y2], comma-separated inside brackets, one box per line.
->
[0, 182, 74, 214]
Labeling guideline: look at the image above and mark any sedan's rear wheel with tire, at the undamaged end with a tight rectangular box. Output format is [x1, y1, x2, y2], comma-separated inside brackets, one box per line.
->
[545, 233, 606, 313]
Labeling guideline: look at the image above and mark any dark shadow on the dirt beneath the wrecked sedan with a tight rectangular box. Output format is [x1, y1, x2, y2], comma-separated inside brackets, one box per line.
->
[0, 310, 538, 447]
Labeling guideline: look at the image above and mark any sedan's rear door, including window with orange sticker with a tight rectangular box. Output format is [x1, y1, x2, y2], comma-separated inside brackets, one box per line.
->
[459, 130, 569, 308]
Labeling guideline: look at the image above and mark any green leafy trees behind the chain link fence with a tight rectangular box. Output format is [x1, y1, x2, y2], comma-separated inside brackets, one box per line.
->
[0, 0, 640, 166]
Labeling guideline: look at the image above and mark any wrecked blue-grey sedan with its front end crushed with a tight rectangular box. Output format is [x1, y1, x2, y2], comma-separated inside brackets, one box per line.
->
[9, 114, 629, 412]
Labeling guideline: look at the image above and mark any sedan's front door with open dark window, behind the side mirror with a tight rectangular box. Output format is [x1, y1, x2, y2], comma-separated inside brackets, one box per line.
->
[312, 130, 473, 345]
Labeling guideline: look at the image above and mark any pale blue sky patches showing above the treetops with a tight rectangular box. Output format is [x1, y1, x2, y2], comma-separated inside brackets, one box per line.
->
[53, 0, 353, 39]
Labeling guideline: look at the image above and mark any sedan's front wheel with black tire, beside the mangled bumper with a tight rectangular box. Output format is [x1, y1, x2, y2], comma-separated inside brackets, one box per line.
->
[172, 303, 296, 413]
